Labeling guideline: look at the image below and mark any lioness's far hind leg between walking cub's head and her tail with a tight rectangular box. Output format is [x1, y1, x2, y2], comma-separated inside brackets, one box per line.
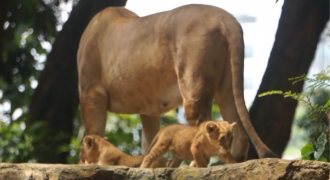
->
[215, 86, 249, 162]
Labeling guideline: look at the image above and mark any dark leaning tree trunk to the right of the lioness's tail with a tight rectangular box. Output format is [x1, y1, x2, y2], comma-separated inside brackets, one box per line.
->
[248, 0, 329, 159]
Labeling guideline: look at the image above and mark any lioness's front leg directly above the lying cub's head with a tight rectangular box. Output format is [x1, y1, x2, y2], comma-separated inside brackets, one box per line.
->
[80, 86, 108, 137]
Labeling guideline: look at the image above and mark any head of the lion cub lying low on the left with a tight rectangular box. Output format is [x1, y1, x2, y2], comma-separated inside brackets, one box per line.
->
[79, 135, 107, 164]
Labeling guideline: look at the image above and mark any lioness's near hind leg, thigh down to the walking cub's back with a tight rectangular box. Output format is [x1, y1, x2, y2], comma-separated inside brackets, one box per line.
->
[175, 34, 222, 126]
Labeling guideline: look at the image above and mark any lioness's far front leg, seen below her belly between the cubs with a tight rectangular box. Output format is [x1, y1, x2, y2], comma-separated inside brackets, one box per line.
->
[140, 114, 161, 154]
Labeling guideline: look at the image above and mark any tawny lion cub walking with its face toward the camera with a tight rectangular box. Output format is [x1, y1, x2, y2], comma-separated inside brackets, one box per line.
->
[140, 121, 236, 168]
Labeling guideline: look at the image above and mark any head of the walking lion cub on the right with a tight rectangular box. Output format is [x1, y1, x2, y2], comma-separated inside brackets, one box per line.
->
[205, 121, 236, 153]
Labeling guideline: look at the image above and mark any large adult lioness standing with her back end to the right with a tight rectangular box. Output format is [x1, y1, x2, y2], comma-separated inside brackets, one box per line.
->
[77, 5, 275, 162]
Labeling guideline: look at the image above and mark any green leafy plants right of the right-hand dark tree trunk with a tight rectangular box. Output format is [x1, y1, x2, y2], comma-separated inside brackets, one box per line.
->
[259, 66, 330, 161]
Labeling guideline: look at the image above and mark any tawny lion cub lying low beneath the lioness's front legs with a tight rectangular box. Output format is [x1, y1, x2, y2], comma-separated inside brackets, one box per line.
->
[79, 135, 167, 168]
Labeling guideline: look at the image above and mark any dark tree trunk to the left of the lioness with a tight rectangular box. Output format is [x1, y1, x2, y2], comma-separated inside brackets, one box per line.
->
[27, 0, 127, 163]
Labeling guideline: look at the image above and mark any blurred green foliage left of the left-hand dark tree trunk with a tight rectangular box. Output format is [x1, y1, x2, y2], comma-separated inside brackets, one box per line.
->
[0, 0, 69, 162]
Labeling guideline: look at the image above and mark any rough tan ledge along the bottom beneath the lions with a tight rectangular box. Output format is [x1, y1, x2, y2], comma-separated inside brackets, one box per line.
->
[0, 158, 330, 180]
